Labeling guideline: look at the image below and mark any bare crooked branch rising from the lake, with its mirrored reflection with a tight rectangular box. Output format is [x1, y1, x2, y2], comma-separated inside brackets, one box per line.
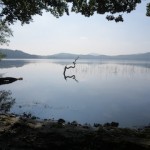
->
[63, 56, 79, 82]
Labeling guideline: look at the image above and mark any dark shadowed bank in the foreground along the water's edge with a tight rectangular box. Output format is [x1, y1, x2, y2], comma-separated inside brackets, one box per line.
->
[0, 114, 150, 150]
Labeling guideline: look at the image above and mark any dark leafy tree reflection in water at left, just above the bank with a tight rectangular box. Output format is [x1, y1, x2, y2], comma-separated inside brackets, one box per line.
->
[0, 90, 15, 113]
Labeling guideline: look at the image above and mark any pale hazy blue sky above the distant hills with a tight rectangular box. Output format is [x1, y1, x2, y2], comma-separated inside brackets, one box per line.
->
[0, 0, 150, 55]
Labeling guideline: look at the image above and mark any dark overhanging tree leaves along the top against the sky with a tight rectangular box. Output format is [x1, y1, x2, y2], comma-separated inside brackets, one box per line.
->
[0, 0, 150, 44]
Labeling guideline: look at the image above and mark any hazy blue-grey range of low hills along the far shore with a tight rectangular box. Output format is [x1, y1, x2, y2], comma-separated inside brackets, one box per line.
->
[0, 49, 150, 61]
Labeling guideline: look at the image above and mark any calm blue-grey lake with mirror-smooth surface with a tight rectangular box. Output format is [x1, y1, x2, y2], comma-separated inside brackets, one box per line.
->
[0, 59, 150, 127]
